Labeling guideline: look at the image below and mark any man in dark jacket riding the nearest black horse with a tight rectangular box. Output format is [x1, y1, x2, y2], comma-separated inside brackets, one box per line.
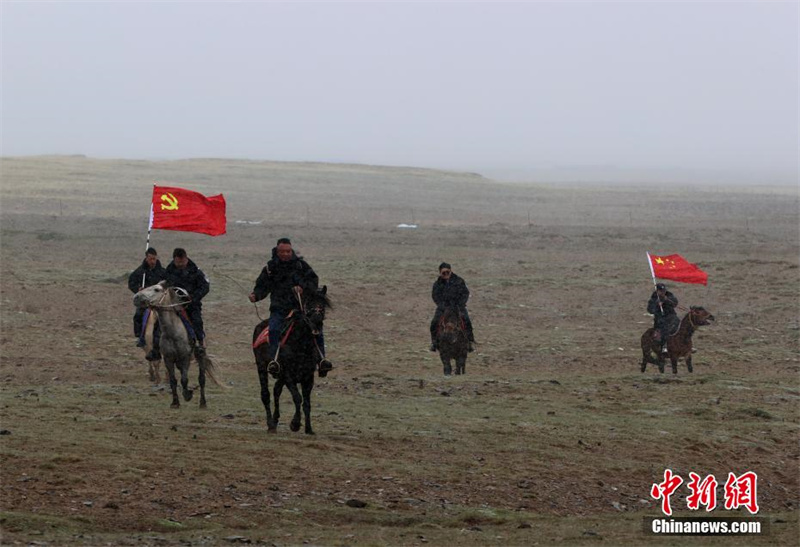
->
[244, 237, 333, 377]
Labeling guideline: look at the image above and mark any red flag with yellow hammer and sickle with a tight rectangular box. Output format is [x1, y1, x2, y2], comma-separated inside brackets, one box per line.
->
[152, 186, 225, 236]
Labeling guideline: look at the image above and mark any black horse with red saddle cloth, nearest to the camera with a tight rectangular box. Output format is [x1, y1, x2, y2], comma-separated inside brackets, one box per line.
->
[253, 286, 331, 435]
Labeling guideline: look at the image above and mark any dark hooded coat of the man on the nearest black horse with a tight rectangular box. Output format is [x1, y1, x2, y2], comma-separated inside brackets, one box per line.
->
[253, 247, 319, 313]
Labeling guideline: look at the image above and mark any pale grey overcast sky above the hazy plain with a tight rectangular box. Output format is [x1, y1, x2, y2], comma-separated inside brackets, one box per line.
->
[0, 0, 799, 184]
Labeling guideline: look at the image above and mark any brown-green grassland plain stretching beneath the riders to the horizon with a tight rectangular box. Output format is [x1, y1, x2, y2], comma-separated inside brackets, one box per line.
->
[0, 157, 800, 545]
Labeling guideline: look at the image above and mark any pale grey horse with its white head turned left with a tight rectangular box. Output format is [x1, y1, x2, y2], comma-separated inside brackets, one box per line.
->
[133, 281, 222, 408]
